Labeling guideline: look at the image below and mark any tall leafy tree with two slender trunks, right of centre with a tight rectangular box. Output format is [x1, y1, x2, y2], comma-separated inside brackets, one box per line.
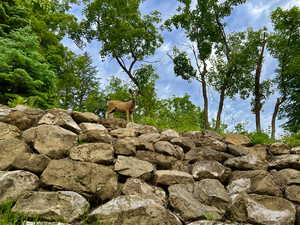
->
[165, 0, 245, 129]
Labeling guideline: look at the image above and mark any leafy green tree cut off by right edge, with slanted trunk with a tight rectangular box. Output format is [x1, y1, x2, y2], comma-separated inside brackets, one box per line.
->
[269, 7, 300, 135]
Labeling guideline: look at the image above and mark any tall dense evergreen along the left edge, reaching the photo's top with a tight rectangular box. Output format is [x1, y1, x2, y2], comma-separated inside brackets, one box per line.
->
[0, 1, 56, 108]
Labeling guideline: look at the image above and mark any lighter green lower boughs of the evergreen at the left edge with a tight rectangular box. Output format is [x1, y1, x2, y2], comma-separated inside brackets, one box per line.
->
[0, 27, 56, 108]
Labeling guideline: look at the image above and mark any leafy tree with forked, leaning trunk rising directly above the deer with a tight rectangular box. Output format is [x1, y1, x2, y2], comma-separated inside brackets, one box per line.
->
[74, 0, 163, 90]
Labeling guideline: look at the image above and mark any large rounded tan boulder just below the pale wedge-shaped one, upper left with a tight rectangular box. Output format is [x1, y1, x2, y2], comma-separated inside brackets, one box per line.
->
[23, 125, 78, 159]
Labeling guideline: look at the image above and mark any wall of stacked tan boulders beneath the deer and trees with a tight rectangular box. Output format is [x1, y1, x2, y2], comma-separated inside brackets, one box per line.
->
[0, 106, 300, 225]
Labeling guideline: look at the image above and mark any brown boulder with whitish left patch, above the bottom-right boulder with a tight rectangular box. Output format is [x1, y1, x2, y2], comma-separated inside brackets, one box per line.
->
[227, 170, 282, 196]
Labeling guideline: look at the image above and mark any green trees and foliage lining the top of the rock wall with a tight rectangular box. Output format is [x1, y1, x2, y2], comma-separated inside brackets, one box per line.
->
[0, 0, 300, 144]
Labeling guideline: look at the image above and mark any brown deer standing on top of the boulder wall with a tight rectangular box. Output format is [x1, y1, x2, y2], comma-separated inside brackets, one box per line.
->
[105, 89, 137, 122]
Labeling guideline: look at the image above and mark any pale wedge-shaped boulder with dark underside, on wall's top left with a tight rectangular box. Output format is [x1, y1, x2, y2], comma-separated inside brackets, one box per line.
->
[38, 112, 81, 134]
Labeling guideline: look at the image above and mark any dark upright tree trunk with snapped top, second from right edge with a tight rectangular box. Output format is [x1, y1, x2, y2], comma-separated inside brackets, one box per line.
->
[253, 33, 267, 132]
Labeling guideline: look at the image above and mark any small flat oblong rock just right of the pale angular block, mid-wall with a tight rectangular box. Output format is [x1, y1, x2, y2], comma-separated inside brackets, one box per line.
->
[155, 170, 194, 185]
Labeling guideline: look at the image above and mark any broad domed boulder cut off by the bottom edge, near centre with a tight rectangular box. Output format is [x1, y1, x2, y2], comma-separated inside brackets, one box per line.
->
[88, 195, 182, 225]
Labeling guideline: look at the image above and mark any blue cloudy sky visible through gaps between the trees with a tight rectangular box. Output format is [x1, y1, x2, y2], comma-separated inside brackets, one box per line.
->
[62, 0, 300, 137]
